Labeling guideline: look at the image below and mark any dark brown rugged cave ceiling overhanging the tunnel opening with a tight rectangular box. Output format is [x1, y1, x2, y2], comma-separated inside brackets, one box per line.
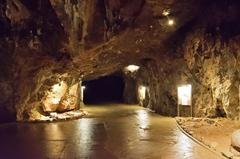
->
[6, 0, 203, 79]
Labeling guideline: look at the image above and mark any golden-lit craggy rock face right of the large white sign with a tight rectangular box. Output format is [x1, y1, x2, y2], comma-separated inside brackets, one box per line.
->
[184, 30, 240, 118]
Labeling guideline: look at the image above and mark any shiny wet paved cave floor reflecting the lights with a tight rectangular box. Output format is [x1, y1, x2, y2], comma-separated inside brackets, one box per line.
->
[0, 104, 218, 159]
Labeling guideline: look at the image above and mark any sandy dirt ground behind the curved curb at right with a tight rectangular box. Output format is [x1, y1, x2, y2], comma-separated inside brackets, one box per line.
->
[177, 118, 240, 156]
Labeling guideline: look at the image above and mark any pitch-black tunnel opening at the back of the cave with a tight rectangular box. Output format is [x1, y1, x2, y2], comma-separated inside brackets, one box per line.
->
[83, 75, 124, 104]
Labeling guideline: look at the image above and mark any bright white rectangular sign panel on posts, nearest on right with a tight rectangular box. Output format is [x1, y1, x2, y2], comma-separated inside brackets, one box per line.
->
[178, 84, 192, 105]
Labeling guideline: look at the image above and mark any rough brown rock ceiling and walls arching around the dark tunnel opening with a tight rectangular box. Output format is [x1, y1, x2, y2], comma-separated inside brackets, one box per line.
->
[0, 0, 240, 121]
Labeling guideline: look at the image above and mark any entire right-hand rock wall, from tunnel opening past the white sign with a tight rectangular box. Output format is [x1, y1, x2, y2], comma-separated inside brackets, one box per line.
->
[138, 30, 240, 118]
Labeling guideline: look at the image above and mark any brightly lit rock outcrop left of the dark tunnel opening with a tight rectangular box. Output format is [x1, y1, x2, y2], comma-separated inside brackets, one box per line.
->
[28, 74, 80, 120]
